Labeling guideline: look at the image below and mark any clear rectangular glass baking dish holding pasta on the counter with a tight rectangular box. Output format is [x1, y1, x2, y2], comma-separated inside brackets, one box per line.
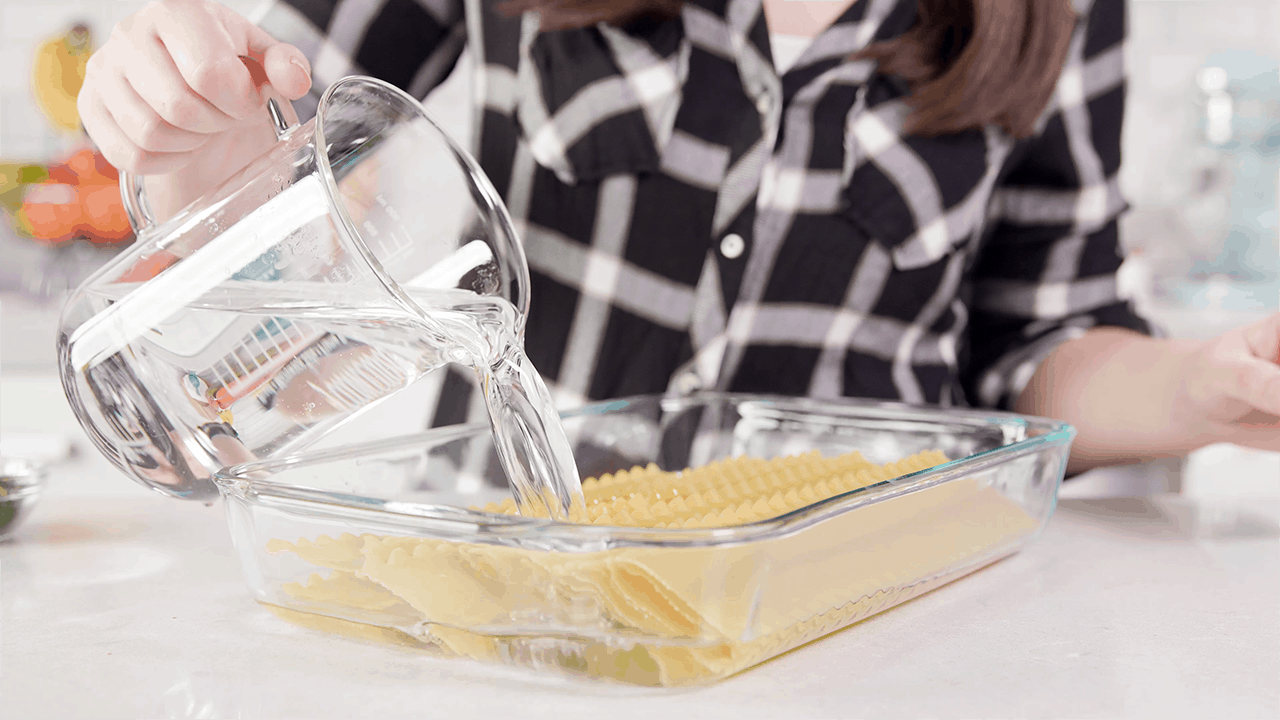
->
[218, 393, 1075, 685]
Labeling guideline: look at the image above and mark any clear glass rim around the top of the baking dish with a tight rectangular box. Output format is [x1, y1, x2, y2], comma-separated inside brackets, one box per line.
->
[214, 392, 1076, 552]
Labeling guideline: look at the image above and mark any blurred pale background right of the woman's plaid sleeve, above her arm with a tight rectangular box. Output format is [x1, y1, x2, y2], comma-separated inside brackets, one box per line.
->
[1120, 0, 1280, 336]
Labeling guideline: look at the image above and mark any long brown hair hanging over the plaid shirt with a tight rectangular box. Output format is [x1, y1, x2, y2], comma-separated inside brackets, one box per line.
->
[499, 0, 1075, 137]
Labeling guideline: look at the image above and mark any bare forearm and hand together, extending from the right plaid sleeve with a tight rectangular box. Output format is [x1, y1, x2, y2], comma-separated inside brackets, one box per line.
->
[1016, 314, 1280, 473]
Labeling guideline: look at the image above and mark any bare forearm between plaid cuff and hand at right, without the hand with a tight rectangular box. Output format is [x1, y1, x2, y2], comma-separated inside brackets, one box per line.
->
[1016, 328, 1212, 473]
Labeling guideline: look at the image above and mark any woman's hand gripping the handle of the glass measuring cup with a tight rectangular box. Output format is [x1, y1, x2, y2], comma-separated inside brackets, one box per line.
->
[77, 0, 311, 215]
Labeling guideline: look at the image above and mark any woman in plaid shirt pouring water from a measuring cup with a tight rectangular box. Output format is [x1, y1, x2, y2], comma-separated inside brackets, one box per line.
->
[79, 0, 1280, 470]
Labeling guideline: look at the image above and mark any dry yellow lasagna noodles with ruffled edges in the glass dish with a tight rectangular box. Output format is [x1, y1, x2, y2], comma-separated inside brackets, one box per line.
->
[268, 451, 1037, 685]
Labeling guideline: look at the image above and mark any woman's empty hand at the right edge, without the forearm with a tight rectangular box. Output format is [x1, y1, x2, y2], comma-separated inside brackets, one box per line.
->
[1174, 313, 1280, 451]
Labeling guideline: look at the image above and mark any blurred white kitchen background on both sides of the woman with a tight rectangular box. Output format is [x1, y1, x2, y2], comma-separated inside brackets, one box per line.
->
[0, 0, 1280, 492]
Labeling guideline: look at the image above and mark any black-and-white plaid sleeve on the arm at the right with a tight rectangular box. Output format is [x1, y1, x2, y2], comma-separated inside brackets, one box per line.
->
[963, 0, 1151, 409]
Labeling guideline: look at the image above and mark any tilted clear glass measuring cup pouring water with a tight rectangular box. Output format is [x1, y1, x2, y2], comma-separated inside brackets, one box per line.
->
[58, 77, 529, 498]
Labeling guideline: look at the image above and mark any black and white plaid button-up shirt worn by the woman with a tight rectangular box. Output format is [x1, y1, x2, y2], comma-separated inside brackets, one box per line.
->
[259, 0, 1147, 423]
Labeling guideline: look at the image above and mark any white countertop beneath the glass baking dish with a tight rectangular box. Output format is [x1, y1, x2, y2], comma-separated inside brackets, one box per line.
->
[0, 371, 1280, 720]
